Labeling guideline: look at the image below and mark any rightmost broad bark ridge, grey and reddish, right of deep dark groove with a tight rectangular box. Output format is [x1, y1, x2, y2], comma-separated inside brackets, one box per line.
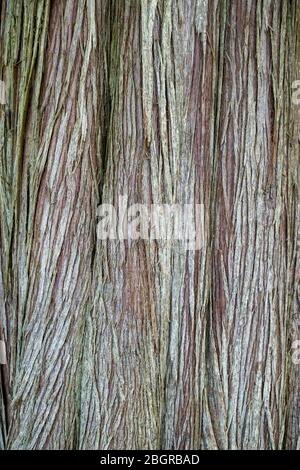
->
[208, 1, 294, 449]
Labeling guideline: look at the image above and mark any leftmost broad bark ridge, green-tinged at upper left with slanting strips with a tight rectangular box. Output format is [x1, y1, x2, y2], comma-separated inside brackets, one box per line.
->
[1, 0, 105, 449]
